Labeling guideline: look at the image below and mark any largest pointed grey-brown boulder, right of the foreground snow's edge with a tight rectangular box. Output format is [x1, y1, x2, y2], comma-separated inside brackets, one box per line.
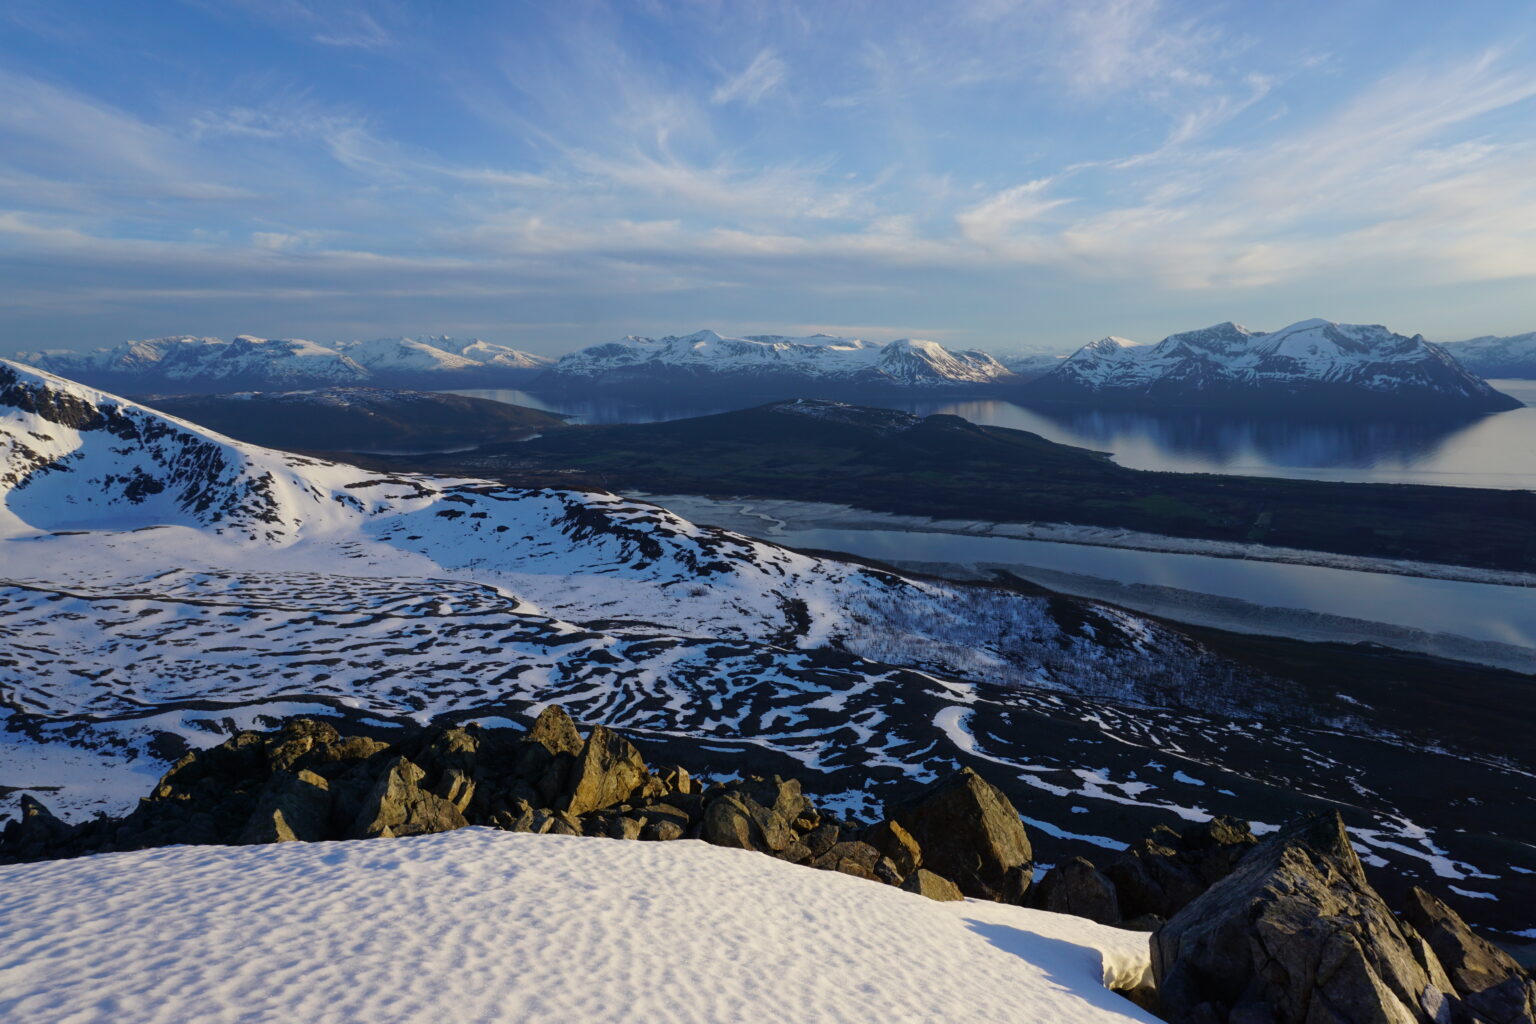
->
[1152, 814, 1453, 1024]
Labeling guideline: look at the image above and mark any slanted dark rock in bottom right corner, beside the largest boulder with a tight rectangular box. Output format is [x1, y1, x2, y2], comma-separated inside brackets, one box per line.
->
[1402, 886, 1536, 1024]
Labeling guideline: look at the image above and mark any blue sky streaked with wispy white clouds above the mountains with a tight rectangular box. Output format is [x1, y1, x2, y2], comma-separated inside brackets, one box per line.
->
[0, 0, 1536, 353]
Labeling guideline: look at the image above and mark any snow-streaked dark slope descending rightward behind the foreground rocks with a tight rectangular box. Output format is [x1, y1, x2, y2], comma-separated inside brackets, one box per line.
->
[0, 362, 1536, 927]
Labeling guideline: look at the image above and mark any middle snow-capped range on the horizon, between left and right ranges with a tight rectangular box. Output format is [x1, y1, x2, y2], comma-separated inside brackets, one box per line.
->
[547, 330, 1014, 391]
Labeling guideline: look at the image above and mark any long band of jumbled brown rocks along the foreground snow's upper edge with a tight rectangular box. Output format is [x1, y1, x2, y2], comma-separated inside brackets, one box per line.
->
[0, 706, 983, 898]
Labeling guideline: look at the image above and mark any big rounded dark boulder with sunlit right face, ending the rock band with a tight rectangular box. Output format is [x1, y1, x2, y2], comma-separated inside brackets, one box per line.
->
[889, 768, 1034, 903]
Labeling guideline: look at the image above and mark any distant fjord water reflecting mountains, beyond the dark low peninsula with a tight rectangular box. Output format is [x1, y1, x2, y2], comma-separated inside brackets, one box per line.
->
[456, 381, 1536, 488]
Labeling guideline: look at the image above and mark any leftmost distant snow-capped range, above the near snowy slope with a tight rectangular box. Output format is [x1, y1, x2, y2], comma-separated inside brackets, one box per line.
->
[18, 335, 553, 393]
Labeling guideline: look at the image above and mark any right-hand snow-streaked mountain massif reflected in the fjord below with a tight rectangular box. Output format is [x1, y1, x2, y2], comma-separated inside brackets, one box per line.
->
[1023, 319, 1519, 415]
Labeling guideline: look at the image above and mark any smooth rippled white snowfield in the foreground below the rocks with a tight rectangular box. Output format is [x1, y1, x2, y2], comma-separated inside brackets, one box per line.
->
[0, 829, 1157, 1024]
